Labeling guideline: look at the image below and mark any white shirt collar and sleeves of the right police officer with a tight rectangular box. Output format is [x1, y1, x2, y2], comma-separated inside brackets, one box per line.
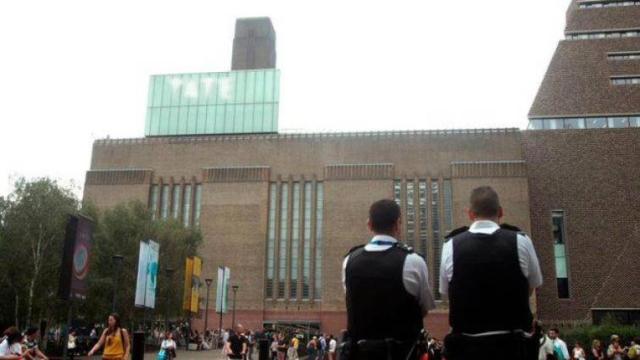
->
[440, 220, 542, 296]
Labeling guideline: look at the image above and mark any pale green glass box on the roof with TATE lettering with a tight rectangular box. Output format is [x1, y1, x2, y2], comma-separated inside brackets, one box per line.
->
[145, 69, 280, 136]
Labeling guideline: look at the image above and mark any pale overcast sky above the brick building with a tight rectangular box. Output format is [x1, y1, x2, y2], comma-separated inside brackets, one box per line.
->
[0, 0, 569, 196]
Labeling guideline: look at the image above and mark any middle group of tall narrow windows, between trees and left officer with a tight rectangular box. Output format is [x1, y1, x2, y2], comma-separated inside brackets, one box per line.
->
[265, 181, 324, 300]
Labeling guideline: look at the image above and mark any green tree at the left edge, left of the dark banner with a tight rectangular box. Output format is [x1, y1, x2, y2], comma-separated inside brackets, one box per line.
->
[0, 178, 78, 325]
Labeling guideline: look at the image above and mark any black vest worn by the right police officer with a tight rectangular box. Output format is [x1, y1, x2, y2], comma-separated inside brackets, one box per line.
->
[449, 229, 533, 334]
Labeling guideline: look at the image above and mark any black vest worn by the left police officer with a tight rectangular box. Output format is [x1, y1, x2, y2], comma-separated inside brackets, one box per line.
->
[345, 245, 423, 341]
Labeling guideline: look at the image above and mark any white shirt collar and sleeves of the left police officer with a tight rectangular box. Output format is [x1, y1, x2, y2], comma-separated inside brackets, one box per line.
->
[342, 235, 436, 316]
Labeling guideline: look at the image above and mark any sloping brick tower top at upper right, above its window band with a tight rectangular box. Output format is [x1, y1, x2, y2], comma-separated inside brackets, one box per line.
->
[529, 0, 640, 130]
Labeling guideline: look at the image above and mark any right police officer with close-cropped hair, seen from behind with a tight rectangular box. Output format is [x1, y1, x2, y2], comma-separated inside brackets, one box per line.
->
[440, 186, 542, 360]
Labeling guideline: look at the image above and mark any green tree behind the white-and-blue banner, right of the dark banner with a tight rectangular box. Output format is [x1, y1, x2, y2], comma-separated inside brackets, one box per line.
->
[81, 202, 202, 328]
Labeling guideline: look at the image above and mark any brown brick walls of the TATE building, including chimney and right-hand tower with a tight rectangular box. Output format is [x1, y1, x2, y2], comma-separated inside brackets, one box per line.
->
[84, 1, 640, 336]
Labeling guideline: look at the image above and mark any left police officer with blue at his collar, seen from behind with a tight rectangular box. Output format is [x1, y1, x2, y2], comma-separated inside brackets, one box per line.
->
[341, 200, 435, 360]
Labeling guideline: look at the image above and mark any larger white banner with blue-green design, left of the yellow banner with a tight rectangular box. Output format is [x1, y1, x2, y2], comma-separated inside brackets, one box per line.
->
[135, 240, 160, 309]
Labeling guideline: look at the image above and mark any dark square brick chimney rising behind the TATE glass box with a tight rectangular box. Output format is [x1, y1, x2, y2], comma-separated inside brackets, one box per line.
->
[231, 17, 276, 70]
